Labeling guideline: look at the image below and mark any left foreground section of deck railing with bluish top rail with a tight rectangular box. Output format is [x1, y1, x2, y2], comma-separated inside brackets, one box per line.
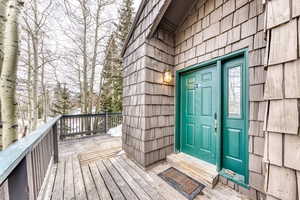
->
[0, 116, 61, 200]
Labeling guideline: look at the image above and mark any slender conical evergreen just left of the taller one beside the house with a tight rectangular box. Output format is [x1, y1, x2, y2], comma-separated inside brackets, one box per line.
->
[100, 32, 118, 112]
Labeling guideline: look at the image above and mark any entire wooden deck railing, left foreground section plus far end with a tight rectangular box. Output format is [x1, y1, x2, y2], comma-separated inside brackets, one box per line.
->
[0, 113, 122, 200]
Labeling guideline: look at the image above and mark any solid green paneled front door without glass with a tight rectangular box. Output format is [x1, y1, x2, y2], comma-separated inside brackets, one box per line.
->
[180, 65, 217, 164]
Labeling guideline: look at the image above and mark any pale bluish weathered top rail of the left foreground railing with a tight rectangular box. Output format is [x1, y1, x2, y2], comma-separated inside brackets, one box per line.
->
[0, 116, 61, 185]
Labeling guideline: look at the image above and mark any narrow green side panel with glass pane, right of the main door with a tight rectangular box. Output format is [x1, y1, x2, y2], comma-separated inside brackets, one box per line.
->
[221, 57, 247, 176]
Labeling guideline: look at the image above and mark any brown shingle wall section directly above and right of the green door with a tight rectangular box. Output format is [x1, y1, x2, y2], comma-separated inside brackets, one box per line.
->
[175, 0, 268, 199]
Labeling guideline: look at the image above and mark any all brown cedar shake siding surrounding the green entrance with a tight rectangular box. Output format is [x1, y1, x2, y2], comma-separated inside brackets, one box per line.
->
[122, 0, 300, 200]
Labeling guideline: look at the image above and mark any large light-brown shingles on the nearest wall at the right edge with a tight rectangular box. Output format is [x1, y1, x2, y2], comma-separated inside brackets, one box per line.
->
[264, 0, 300, 200]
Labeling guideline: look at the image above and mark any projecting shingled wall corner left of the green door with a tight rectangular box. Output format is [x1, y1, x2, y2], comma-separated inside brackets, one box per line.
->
[122, 0, 174, 167]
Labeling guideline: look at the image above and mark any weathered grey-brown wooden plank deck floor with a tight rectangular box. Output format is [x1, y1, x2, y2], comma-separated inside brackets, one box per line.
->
[42, 137, 246, 200]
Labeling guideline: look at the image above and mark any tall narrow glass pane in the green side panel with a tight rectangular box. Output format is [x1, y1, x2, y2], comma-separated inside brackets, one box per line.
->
[228, 67, 241, 117]
